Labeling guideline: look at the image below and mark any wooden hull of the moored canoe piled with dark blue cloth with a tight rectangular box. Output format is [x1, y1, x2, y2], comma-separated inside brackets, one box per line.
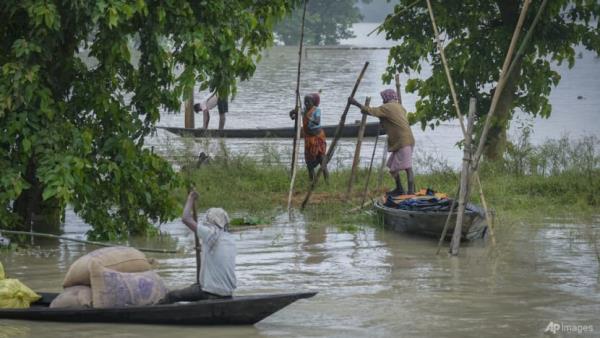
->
[374, 201, 487, 240]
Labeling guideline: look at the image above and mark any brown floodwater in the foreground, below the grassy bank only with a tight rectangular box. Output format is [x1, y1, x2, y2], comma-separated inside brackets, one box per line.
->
[0, 213, 600, 337]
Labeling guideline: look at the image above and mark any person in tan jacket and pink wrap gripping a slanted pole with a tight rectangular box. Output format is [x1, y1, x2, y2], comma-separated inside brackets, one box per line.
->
[348, 89, 415, 196]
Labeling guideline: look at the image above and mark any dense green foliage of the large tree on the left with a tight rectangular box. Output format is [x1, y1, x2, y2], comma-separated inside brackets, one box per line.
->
[0, 0, 299, 239]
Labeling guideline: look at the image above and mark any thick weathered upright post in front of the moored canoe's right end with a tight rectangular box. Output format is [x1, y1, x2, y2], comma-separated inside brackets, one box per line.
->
[450, 98, 477, 256]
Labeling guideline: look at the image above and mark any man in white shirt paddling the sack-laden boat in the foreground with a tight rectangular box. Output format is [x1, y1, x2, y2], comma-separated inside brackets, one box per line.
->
[163, 191, 237, 303]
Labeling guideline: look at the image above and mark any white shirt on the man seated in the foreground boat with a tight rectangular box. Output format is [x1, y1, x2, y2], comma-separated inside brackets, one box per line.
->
[197, 224, 237, 296]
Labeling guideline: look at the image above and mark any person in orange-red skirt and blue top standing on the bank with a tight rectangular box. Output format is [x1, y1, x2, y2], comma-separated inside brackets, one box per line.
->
[290, 93, 329, 181]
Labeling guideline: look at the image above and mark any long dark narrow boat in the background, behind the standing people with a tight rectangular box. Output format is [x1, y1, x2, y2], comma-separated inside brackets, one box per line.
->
[157, 122, 385, 138]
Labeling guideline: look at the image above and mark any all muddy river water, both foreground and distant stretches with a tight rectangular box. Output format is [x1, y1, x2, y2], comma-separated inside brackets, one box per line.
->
[0, 25, 600, 338]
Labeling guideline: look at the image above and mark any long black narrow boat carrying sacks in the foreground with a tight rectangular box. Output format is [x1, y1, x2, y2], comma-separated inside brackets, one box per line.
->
[0, 292, 317, 325]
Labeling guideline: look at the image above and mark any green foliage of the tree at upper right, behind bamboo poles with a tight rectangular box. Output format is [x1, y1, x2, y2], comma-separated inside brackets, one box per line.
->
[382, 0, 600, 143]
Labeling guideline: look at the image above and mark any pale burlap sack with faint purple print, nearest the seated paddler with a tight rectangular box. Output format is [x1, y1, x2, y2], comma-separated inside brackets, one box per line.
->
[90, 260, 168, 308]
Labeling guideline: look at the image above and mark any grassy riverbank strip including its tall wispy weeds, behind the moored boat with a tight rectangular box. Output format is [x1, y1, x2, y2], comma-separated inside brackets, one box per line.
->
[180, 137, 600, 226]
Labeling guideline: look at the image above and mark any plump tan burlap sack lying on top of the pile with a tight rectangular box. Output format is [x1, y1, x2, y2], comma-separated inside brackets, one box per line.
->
[63, 246, 152, 288]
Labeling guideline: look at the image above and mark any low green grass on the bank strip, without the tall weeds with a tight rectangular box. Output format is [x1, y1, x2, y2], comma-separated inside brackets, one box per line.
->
[176, 156, 600, 225]
